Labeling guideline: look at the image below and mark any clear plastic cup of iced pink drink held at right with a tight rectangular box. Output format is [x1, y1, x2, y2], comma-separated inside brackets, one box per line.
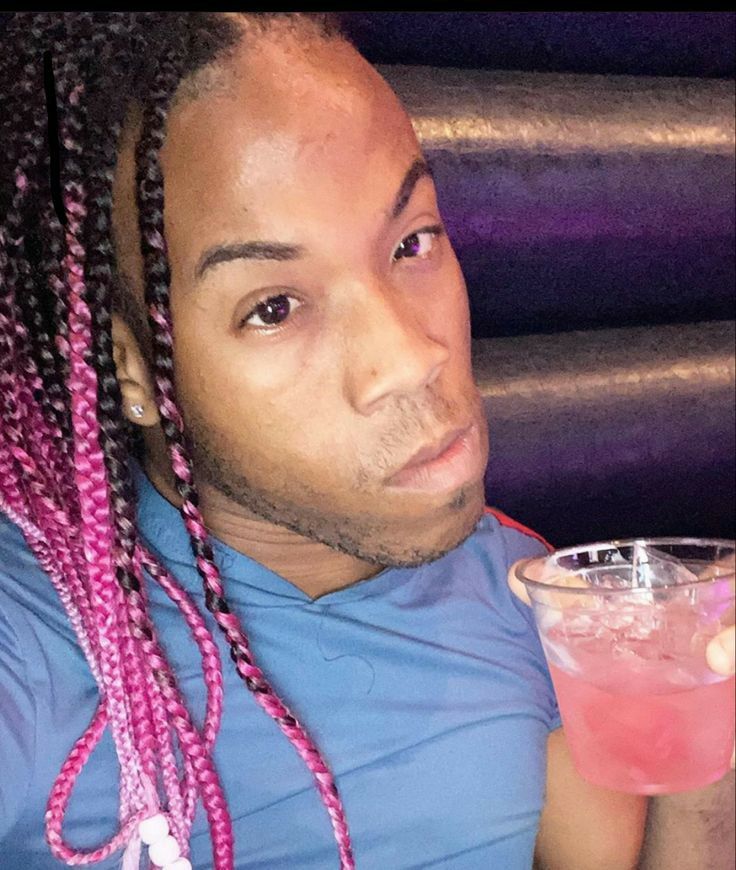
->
[516, 538, 735, 794]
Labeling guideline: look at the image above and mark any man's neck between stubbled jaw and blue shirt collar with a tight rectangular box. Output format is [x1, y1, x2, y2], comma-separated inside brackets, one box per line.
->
[146, 463, 382, 598]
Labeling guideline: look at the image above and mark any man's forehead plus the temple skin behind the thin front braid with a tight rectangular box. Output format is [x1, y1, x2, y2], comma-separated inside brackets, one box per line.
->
[113, 29, 419, 299]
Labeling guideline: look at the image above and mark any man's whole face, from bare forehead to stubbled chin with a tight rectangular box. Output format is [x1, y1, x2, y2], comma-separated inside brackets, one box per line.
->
[116, 28, 487, 564]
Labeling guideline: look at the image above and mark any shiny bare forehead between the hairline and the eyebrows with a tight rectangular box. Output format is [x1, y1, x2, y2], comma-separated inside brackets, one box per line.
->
[161, 33, 418, 238]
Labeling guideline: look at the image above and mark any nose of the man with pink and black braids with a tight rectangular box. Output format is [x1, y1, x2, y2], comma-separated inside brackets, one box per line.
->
[345, 285, 450, 415]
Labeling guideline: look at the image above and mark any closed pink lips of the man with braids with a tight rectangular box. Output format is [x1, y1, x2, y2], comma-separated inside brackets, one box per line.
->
[386, 424, 485, 492]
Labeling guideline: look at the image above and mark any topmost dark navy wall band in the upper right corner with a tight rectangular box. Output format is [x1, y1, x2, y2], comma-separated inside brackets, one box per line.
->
[343, 12, 736, 78]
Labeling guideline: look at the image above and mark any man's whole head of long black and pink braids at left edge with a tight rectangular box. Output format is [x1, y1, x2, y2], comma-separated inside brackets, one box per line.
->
[0, 12, 353, 870]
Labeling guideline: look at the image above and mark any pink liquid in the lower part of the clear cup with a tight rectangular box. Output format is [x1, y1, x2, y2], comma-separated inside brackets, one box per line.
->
[550, 642, 735, 794]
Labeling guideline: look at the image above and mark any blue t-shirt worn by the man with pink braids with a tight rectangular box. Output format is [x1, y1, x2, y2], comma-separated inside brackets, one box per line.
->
[0, 476, 560, 870]
